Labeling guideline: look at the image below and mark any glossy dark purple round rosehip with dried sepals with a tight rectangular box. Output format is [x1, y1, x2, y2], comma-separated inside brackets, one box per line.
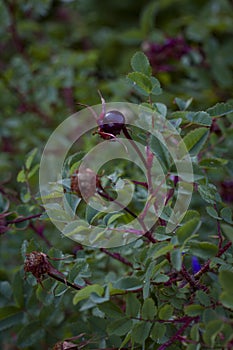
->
[100, 111, 125, 136]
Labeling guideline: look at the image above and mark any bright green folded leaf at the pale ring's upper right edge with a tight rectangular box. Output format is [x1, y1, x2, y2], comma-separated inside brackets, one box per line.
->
[183, 128, 209, 156]
